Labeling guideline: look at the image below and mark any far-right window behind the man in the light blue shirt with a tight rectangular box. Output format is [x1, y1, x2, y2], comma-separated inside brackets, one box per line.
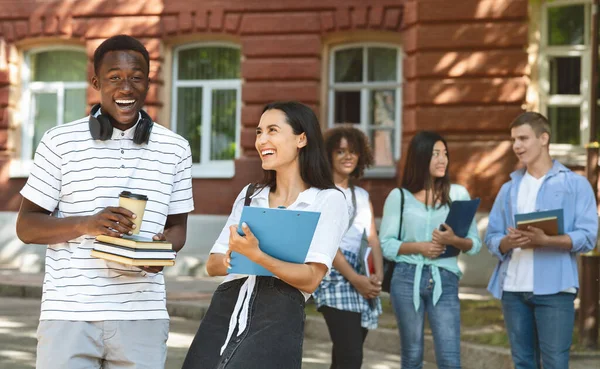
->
[540, 0, 600, 147]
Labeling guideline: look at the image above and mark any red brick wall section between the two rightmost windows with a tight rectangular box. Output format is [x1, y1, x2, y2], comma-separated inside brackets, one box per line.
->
[399, 0, 528, 210]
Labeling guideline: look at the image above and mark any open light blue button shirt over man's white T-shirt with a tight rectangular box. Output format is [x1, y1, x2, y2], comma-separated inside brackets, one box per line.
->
[485, 161, 598, 299]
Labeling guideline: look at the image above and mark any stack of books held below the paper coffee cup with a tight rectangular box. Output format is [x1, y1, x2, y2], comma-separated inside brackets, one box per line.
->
[92, 235, 175, 266]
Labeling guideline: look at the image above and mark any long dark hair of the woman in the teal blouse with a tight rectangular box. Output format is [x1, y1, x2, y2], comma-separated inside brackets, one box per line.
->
[402, 131, 451, 207]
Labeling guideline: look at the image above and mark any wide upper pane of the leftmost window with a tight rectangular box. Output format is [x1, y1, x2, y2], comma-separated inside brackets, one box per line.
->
[30, 50, 87, 82]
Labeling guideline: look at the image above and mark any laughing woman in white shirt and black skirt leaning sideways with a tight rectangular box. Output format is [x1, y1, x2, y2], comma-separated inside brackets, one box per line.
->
[183, 102, 348, 369]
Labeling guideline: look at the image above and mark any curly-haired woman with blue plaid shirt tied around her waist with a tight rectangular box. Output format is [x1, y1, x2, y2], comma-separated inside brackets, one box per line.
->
[313, 127, 383, 369]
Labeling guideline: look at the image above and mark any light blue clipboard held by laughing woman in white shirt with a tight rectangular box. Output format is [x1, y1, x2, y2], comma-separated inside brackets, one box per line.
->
[228, 206, 321, 276]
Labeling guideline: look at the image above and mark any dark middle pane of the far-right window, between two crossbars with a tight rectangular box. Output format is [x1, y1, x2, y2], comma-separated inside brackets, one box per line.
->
[549, 57, 581, 95]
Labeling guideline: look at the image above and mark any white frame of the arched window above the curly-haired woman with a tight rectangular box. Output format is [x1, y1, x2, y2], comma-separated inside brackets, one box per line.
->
[327, 42, 404, 178]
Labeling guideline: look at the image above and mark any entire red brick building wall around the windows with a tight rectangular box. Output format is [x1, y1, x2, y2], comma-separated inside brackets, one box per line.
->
[0, 0, 527, 214]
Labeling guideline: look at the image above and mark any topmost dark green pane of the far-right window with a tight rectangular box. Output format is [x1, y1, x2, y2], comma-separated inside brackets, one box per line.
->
[548, 4, 585, 45]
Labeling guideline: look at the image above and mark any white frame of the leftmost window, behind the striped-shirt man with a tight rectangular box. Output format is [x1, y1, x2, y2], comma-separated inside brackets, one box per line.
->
[10, 45, 88, 178]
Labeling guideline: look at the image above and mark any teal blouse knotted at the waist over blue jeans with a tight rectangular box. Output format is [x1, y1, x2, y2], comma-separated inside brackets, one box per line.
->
[379, 184, 481, 310]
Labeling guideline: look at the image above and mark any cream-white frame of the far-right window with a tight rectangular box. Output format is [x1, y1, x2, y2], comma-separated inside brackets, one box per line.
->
[538, 0, 594, 158]
